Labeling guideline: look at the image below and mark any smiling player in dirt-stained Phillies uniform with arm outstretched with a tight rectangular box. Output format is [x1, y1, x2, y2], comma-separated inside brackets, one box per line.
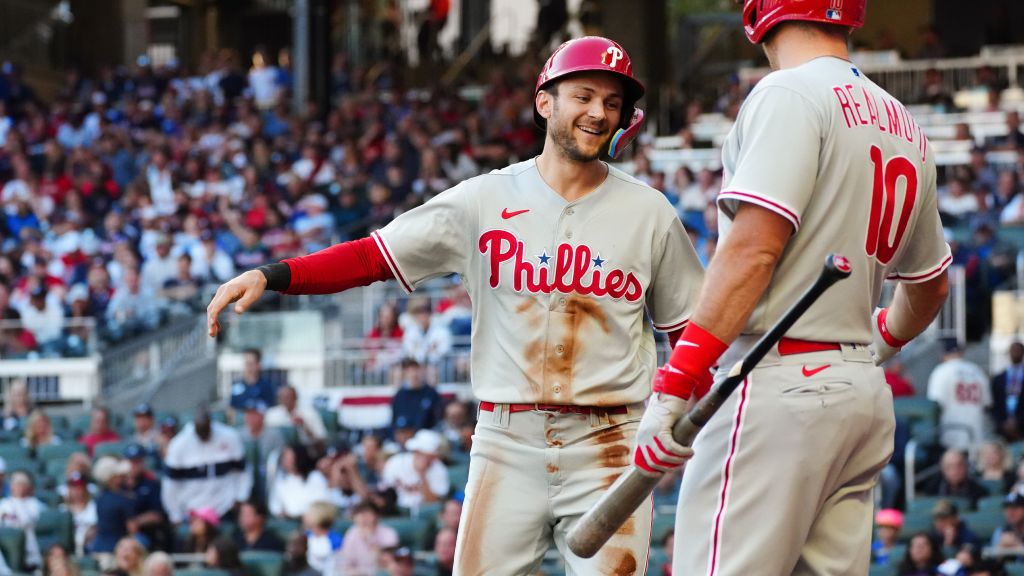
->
[208, 37, 702, 576]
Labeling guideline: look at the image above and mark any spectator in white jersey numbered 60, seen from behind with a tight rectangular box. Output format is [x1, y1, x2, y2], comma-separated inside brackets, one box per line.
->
[928, 341, 992, 450]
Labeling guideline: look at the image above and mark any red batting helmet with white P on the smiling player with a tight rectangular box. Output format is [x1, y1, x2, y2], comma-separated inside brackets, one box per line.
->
[534, 36, 644, 158]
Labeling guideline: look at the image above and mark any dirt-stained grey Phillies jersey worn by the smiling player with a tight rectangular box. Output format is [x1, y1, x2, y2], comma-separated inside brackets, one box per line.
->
[373, 160, 703, 406]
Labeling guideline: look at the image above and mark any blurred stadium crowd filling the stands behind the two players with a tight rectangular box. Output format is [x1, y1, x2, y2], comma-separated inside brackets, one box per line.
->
[0, 20, 1024, 576]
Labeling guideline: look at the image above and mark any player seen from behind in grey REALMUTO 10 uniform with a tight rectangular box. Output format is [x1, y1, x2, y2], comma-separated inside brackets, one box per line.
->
[635, 0, 950, 576]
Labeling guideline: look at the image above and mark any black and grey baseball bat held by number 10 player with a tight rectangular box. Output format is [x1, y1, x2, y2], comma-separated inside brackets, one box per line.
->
[567, 254, 851, 558]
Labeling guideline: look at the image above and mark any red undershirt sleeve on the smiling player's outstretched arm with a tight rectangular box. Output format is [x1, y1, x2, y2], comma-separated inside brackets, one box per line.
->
[284, 238, 394, 294]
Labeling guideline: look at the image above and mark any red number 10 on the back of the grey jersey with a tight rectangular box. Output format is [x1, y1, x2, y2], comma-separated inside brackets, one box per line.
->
[864, 146, 918, 264]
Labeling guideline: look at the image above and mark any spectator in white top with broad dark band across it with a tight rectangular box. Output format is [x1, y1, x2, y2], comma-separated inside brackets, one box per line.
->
[161, 407, 252, 524]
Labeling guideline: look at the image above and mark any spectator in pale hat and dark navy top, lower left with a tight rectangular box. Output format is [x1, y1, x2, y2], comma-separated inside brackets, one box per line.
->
[90, 456, 136, 552]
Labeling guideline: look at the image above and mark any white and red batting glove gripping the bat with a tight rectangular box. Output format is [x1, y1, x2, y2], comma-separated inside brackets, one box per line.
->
[633, 383, 693, 476]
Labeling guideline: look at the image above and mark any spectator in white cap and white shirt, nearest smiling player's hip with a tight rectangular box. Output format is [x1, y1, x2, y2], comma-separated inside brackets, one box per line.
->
[381, 429, 451, 510]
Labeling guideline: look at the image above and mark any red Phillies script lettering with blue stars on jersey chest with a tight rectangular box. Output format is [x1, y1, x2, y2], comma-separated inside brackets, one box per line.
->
[480, 230, 643, 302]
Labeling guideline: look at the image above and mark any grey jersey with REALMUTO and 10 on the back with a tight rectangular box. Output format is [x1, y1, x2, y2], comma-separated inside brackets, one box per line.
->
[718, 56, 952, 343]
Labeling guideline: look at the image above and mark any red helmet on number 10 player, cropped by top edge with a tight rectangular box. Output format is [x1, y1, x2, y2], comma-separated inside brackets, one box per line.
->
[743, 0, 867, 44]
